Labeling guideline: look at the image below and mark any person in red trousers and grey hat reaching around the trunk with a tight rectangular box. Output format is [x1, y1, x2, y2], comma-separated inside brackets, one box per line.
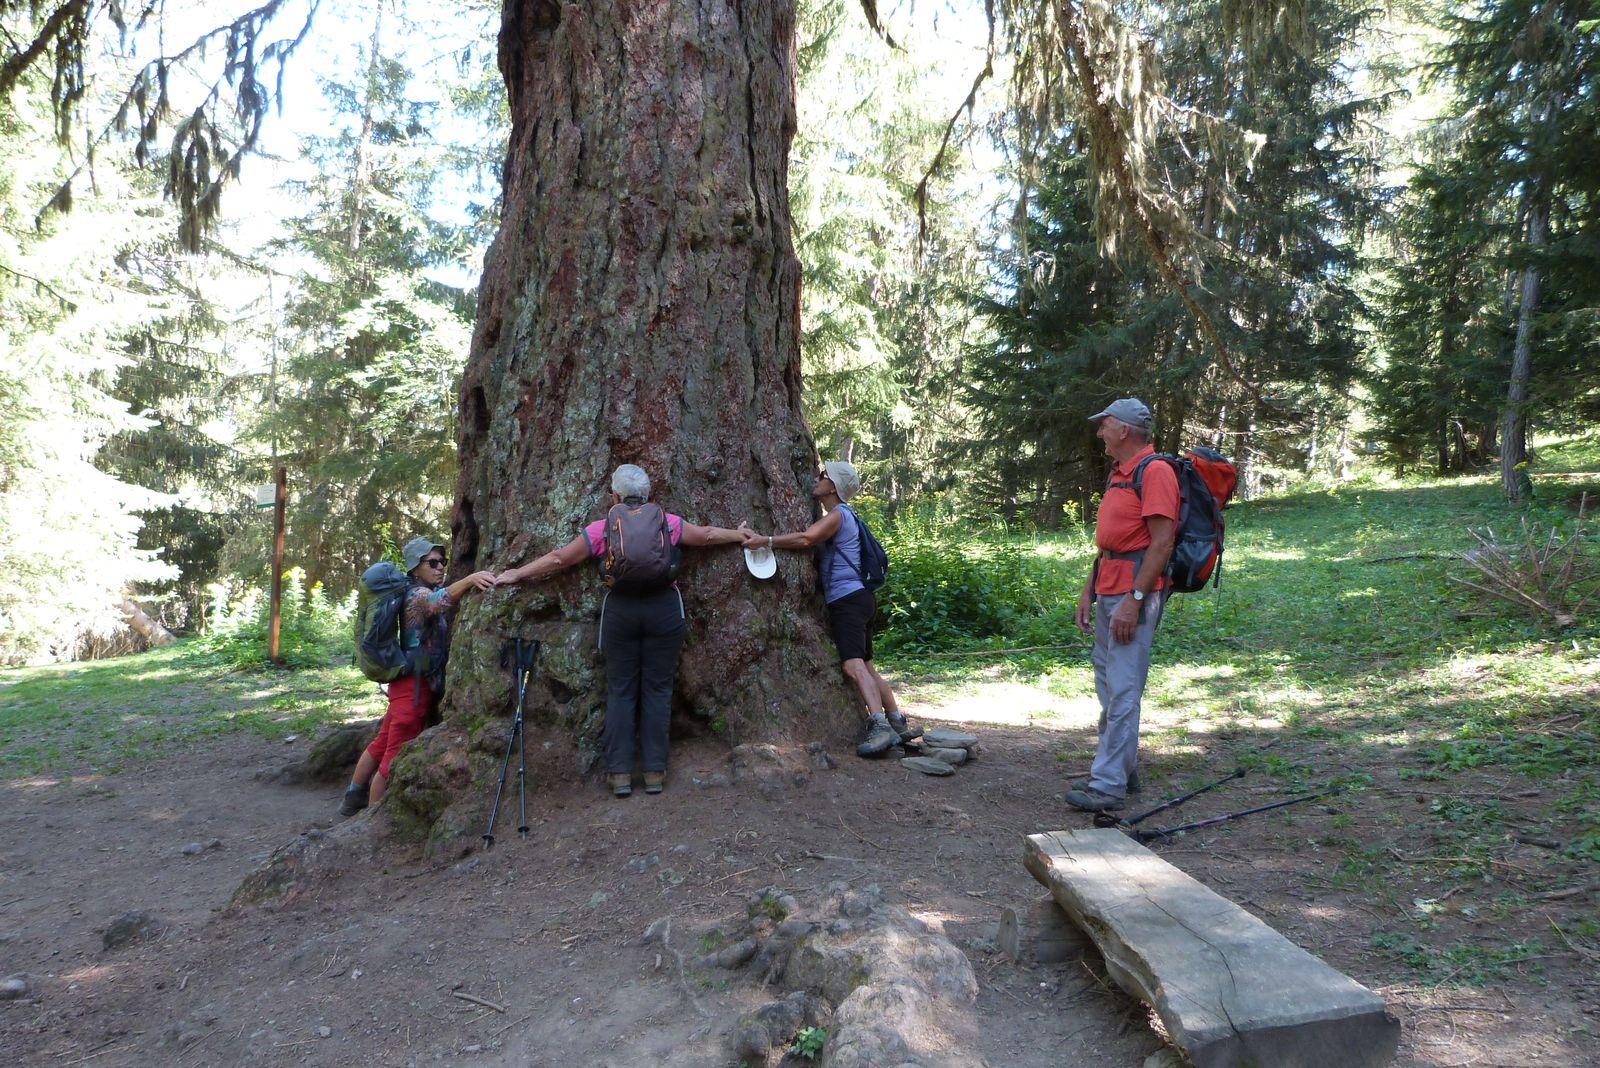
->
[339, 537, 494, 815]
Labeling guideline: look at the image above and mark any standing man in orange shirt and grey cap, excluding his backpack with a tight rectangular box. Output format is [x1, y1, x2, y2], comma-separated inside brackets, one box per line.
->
[1067, 397, 1181, 812]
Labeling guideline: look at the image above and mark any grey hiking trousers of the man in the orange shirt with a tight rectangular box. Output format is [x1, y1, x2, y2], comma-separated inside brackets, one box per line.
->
[1090, 590, 1166, 798]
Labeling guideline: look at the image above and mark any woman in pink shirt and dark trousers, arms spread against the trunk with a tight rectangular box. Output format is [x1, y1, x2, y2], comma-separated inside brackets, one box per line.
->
[496, 464, 744, 798]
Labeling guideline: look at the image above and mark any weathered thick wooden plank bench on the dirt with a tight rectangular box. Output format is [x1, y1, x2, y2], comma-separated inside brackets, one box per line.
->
[1024, 830, 1400, 1068]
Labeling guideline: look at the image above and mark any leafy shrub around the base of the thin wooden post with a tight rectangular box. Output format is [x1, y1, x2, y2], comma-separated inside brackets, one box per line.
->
[195, 568, 355, 671]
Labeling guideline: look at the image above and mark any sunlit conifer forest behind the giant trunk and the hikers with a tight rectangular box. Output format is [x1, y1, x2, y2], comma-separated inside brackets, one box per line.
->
[0, 0, 1600, 664]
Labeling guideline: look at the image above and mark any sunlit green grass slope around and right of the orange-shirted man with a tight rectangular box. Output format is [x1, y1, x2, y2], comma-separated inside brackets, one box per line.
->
[883, 438, 1600, 965]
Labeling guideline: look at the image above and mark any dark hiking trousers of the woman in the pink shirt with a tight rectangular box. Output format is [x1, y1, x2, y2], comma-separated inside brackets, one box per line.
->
[600, 590, 688, 775]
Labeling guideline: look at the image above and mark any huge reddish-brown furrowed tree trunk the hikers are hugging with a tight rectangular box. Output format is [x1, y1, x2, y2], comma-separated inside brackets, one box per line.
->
[385, 0, 853, 838]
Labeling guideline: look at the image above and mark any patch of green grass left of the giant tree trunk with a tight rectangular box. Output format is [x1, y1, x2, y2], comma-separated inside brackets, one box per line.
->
[0, 643, 382, 779]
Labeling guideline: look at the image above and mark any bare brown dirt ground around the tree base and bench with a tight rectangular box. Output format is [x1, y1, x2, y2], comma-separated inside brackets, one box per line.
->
[0, 684, 1600, 1068]
